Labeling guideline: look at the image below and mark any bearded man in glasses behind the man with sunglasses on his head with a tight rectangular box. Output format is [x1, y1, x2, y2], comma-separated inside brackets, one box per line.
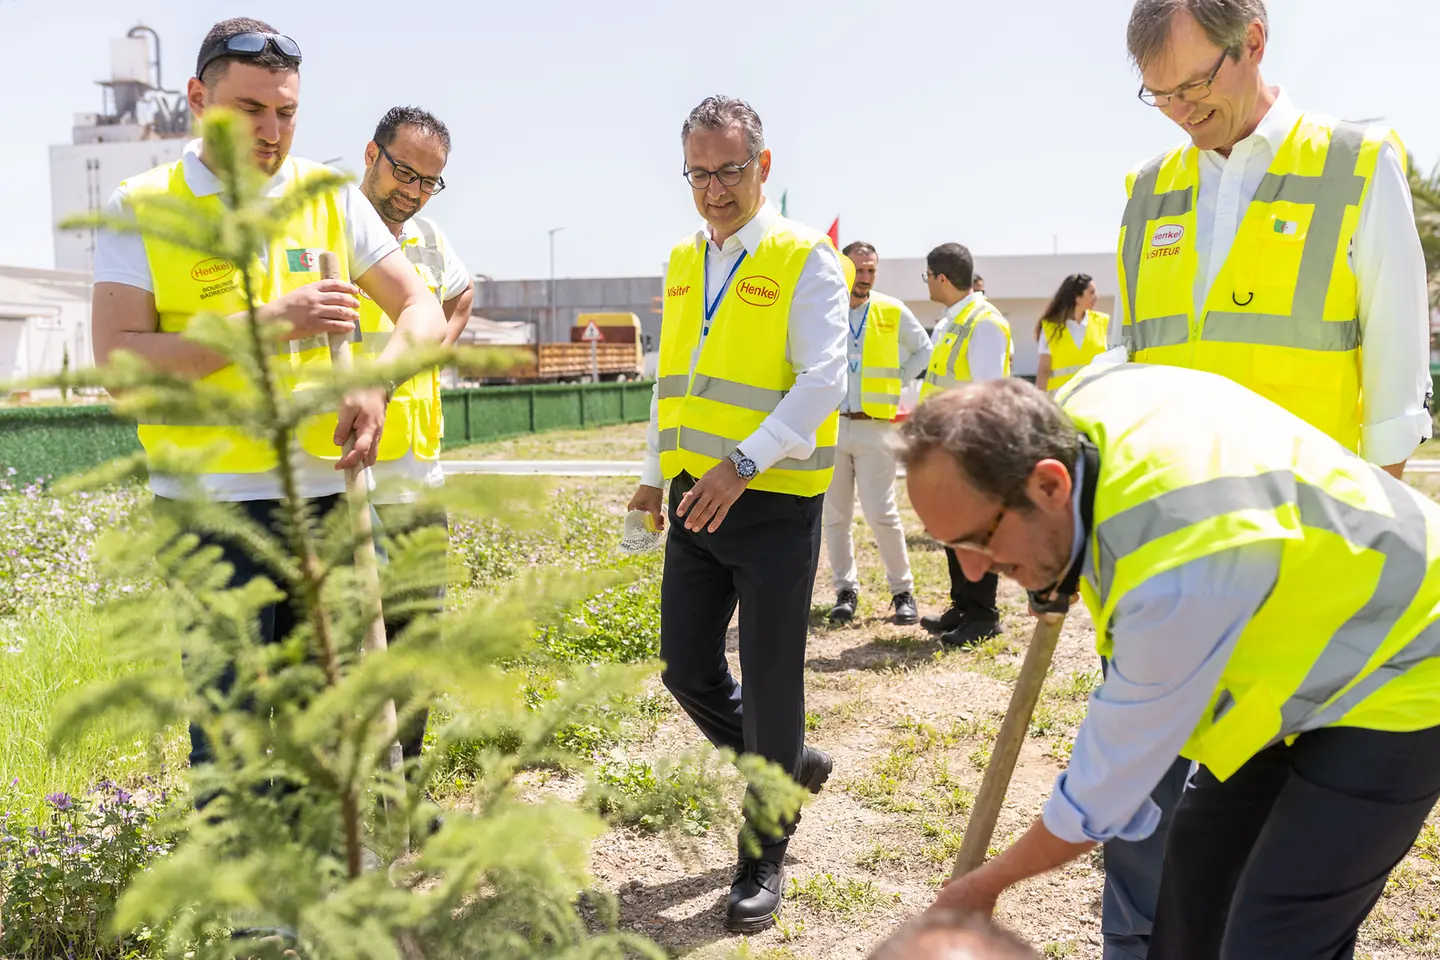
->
[360, 107, 475, 777]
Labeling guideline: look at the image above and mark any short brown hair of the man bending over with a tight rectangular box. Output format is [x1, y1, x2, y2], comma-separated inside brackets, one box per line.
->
[899, 377, 1080, 508]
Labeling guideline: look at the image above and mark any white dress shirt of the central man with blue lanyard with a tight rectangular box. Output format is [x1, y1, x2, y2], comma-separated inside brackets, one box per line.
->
[641, 200, 850, 486]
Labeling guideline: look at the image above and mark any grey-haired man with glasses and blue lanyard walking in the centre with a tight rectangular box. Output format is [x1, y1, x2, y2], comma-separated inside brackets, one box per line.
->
[629, 96, 850, 931]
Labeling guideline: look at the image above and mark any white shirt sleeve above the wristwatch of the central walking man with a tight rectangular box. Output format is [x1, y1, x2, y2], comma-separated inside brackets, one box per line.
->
[740, 243, 850, 472]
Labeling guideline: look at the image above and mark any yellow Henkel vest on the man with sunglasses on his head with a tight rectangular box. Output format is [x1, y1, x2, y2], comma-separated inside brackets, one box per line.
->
[124, 157, 350, 474]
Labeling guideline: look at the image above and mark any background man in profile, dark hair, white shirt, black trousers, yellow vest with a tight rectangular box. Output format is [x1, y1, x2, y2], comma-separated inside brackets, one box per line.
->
[920, 243, 1011, 648]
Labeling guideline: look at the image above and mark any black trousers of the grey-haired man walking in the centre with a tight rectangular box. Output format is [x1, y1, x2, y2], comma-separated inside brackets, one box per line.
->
[660, 474, 824, 859]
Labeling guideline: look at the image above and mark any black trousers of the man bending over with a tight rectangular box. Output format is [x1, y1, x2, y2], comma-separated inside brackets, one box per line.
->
[1149, 727, 1440, 960]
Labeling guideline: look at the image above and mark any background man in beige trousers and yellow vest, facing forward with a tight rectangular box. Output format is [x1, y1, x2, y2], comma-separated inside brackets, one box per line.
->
[824, 240, 930, 623]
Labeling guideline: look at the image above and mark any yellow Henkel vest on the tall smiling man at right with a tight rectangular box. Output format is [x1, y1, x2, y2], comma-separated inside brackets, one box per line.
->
[1119, 114, 1405, 452]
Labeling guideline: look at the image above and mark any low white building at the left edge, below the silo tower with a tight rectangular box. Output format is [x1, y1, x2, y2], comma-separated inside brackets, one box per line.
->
[0, 266, 94, 383]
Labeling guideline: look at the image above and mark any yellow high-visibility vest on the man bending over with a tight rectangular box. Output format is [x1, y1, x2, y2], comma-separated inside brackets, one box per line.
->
[1057, 364, 1440, 779]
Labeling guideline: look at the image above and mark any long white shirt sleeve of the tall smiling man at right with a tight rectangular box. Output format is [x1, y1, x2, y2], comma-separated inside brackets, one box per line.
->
[1354, 144, 1433, 466]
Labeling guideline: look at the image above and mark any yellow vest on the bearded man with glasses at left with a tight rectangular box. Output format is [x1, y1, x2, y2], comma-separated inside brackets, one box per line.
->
[354, 217, 445, 461]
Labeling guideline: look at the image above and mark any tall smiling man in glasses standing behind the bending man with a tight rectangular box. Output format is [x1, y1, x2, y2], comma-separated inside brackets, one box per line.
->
[1092, 0, 1431, 957]
